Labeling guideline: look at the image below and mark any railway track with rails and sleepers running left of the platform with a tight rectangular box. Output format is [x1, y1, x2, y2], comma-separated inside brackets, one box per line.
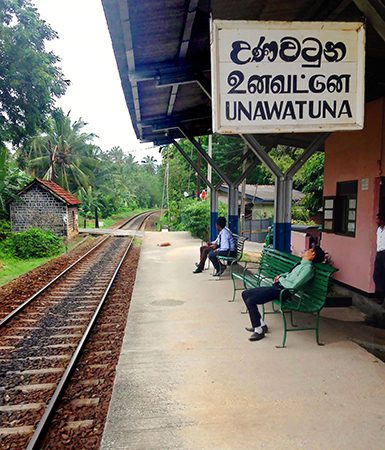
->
[0, 213, 150, 450]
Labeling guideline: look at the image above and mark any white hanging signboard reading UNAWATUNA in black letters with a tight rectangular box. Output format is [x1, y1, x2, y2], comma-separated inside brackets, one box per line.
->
[211, 20, 365, 133]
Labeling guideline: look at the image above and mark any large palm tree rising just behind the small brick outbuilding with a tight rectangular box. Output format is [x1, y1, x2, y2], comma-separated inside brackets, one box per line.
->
[22, 109, 99, 192]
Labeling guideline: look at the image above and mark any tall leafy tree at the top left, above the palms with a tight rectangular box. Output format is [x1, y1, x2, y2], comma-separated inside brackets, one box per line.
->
[0, 0, 66, 144]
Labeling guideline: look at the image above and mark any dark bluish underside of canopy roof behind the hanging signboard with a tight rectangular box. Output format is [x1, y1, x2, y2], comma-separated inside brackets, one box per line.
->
[102, 0, 385, 147]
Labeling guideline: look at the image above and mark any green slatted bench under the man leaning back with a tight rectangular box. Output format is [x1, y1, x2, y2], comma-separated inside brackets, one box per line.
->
[232, 248, 337, 347]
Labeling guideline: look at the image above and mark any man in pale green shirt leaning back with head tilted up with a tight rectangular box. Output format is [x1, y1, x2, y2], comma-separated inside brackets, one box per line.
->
[242, 246, 325, 341]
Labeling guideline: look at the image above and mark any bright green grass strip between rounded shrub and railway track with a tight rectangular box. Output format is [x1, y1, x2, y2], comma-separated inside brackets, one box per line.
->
[0, 237, 84, 286]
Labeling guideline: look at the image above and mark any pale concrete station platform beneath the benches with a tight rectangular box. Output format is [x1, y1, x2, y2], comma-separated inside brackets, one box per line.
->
[102, 232, 385, 450]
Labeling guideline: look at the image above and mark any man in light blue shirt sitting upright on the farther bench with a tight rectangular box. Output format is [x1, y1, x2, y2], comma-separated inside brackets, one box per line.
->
[193, 217, 236, 276]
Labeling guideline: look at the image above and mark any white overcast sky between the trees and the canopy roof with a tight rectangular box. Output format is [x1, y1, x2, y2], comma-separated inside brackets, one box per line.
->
[32, 0, 160, 161]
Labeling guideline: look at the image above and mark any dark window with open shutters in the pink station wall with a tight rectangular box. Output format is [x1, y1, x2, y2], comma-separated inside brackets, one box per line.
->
[323, 181, 358, 237]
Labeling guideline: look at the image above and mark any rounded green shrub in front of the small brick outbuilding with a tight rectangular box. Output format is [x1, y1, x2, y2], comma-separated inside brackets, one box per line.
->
[3, 228, 64, 259]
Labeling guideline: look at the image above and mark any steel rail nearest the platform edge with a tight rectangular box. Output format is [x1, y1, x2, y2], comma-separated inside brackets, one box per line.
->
[27, 238, 134, 450]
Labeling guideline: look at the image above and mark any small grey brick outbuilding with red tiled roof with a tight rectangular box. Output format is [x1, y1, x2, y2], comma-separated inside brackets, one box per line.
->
[10, 178, 81, 239]
